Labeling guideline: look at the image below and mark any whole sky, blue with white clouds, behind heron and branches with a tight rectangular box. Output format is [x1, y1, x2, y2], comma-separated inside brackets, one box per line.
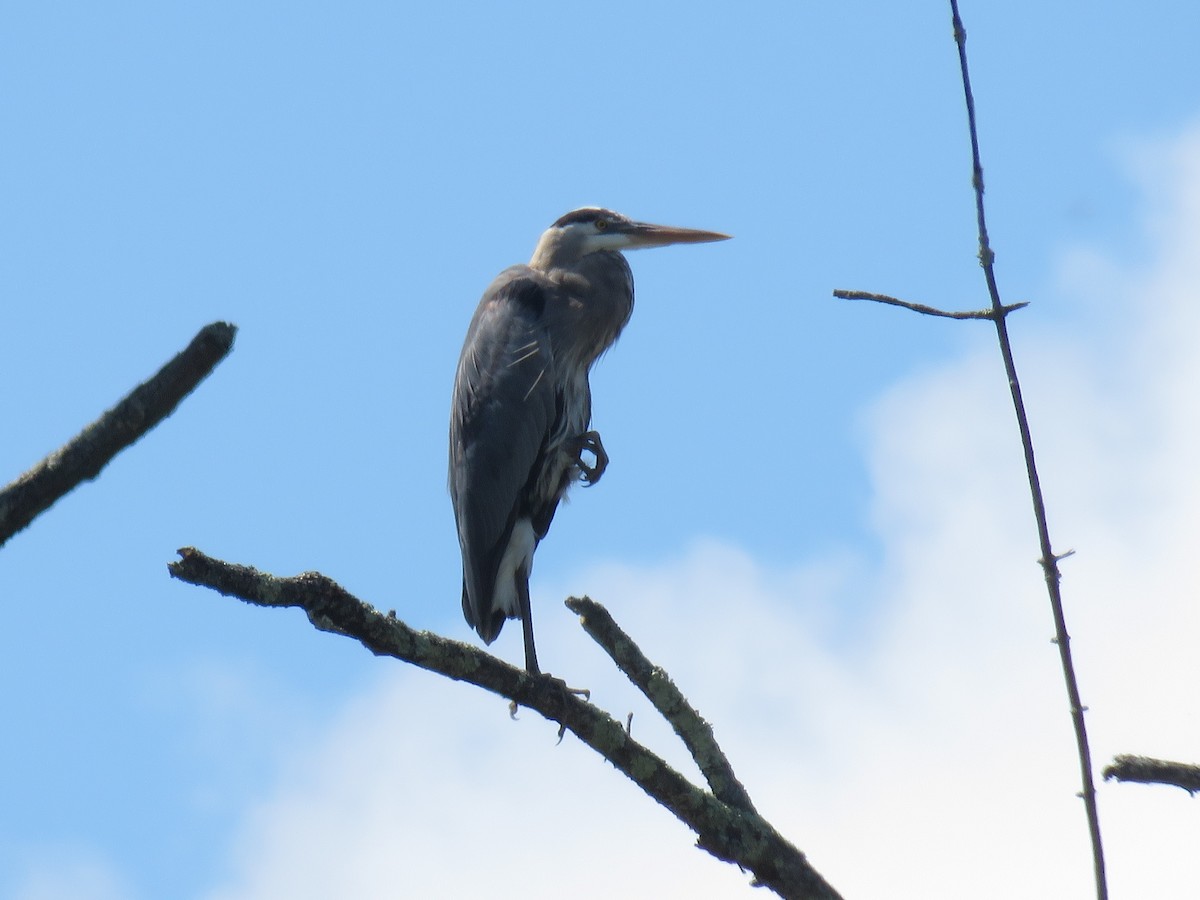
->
[0, 2, 1200, 900]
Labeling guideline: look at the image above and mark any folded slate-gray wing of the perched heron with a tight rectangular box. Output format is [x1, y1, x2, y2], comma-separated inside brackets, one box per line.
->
[450, 266, 556, 642]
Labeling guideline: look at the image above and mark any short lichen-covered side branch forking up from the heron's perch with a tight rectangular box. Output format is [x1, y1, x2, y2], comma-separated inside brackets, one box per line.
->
[566, 596, 755, 812]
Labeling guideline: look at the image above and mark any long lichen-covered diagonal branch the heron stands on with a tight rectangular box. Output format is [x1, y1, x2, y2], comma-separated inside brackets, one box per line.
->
[168, 547, 839, 900]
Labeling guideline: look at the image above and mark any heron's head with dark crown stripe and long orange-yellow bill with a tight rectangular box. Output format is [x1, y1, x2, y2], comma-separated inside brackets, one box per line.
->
[532, 206, 730, 268]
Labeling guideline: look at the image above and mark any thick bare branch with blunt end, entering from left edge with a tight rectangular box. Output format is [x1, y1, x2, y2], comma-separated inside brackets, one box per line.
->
[0, 322, 238, 546]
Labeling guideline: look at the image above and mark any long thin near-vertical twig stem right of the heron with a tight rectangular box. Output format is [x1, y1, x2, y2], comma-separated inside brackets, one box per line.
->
[950, 0, 1109, 900]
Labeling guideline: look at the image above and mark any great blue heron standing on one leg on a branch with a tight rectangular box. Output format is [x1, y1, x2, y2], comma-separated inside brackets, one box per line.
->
[450, 208, 728, 674]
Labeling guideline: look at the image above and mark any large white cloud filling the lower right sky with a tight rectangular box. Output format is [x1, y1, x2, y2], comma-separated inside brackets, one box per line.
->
[199, 125, 1200, 900]
